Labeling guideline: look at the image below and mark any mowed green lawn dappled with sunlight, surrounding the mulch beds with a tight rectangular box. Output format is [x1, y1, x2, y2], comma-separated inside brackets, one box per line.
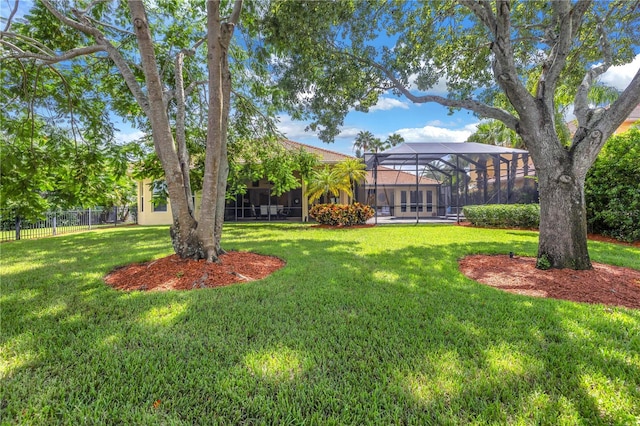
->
[0, 224, 640, 425]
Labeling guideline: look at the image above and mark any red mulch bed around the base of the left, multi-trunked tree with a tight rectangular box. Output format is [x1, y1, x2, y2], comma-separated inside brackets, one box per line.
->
[104, 251, 285, 291]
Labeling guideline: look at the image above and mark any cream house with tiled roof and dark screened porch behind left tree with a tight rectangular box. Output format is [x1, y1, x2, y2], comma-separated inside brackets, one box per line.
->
[137, 140, 351, 225]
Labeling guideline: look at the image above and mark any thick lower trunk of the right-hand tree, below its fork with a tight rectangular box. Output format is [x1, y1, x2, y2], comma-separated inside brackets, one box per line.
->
[537, 165, 591, 270]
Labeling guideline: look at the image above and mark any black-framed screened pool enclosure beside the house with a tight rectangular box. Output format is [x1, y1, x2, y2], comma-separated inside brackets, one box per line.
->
[358, 142, 538, 223]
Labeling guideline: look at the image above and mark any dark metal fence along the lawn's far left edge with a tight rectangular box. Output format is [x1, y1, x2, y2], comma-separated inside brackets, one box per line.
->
[0, 206, 138, 242]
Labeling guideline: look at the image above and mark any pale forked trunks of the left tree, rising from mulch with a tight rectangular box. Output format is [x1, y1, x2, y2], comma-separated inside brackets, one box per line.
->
[129, 0, 242, 262]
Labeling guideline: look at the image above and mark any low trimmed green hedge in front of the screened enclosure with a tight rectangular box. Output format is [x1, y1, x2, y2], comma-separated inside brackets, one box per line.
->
[462, 204, 540, 228]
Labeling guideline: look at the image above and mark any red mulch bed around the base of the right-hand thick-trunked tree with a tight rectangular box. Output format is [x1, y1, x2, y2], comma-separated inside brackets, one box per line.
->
[459, 255, 640, 309]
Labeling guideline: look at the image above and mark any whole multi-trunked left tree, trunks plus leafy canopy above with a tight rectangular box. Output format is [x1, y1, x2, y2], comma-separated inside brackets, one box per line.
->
[0, 0, 288, 261]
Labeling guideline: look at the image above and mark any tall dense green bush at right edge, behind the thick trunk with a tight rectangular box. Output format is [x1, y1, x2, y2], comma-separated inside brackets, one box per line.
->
[585, 128, 640, 242]
